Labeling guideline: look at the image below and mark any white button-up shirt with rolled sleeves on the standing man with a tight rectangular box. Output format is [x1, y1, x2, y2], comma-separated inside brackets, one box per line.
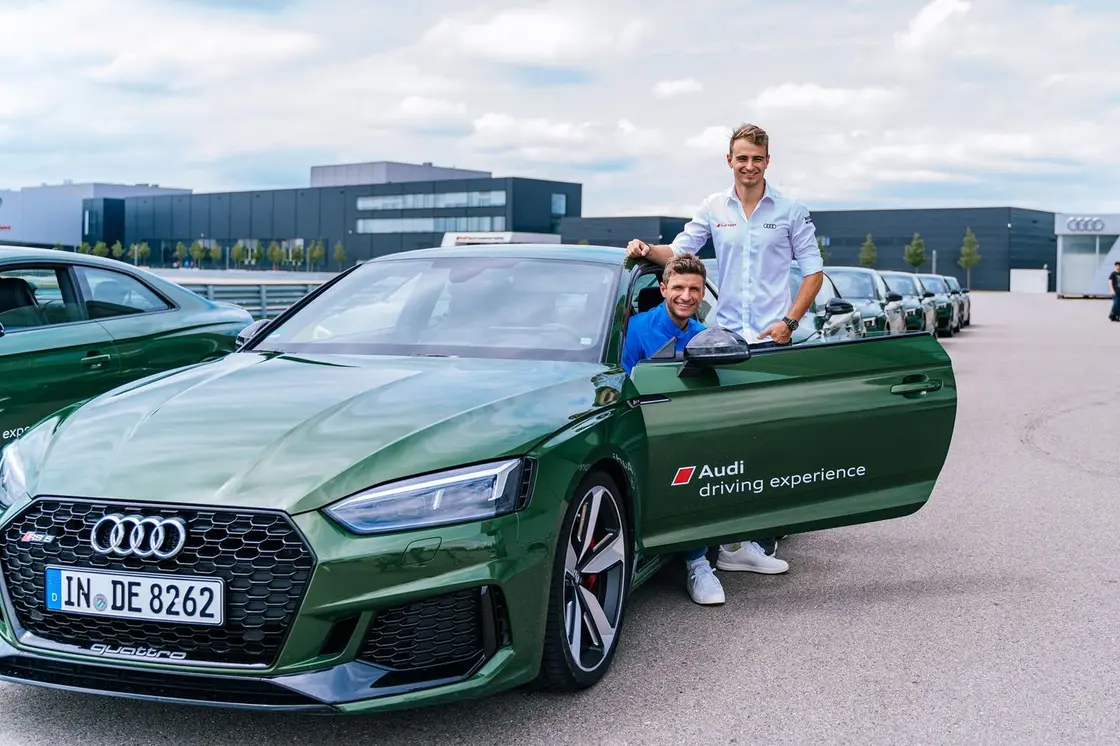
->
[670, 184, 824, 344]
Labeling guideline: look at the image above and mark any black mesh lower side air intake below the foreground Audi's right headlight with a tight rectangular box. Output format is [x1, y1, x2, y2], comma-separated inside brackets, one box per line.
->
[358, 587, 510, 671]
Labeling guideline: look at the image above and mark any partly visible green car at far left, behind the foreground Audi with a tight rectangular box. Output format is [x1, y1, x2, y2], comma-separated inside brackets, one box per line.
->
[0, 246, 253, 447]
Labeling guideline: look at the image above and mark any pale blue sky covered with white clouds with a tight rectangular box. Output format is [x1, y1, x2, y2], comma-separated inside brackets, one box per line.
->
[0, 0, 1120, 215]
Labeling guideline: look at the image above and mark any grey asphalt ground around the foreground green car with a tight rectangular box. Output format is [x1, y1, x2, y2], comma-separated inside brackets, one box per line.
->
[0, 286, 1120, 746]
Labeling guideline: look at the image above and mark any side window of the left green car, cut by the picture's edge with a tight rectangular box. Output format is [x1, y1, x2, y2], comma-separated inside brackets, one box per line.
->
[0, 267, 82, 332]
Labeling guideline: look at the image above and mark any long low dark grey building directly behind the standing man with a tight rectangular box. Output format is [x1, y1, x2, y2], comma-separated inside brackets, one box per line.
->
[561, 207, 1057, 292]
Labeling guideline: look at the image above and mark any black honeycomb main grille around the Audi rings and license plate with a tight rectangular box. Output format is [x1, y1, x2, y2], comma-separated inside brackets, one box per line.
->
[0, 498, 315, 665]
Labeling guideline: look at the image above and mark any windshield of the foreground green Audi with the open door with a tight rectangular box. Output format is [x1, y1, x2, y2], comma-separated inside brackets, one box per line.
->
[254, 257, 618, 362]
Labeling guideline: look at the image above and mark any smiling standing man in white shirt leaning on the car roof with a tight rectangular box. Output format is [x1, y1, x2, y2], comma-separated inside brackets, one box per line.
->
[626, 119, 824, 604]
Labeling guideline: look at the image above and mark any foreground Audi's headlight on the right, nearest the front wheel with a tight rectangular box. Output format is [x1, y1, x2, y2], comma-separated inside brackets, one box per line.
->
[326, 459, 523, 534]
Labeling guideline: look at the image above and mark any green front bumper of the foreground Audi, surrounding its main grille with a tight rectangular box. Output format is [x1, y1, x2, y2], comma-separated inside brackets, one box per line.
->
[0, 495, 552, 712]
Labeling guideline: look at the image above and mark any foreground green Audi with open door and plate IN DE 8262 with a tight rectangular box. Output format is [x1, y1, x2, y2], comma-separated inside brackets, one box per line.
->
[0, 244, 958, 714]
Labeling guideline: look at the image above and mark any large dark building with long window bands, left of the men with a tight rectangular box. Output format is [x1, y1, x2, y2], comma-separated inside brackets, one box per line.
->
[83, 164, 582, 269]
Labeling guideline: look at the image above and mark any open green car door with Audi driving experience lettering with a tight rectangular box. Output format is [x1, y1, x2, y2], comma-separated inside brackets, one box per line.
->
[632, 333, 956, 552]
